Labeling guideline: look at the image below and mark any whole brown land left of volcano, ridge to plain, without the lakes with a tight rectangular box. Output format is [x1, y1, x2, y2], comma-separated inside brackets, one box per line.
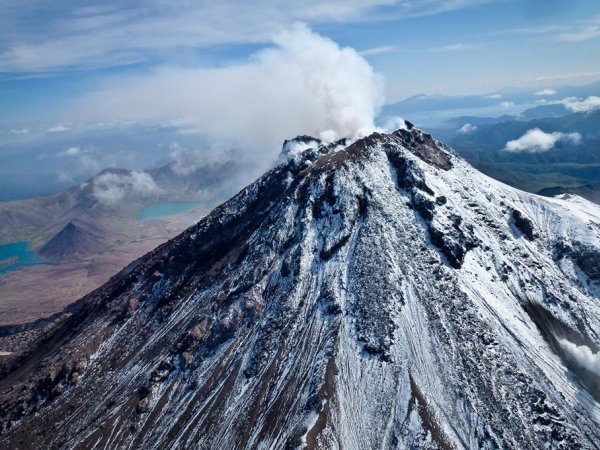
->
[0, 155, 247, 325]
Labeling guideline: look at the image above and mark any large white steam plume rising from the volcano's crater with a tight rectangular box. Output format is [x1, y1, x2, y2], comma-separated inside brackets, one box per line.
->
[70, 24, 384, 158]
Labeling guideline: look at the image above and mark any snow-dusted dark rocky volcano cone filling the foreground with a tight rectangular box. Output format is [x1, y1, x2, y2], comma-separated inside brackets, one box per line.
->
[0, 124, 600, 449]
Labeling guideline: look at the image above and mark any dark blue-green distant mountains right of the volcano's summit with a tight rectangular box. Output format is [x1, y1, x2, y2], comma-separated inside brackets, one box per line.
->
[422, 110, 600, 198]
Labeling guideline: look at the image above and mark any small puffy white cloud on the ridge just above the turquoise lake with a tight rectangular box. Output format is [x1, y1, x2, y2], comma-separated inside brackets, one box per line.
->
[92, 171, 160, 205]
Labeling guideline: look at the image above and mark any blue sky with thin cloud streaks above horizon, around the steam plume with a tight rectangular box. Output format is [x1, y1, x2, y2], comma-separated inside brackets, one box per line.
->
[0, 0, 600, 127]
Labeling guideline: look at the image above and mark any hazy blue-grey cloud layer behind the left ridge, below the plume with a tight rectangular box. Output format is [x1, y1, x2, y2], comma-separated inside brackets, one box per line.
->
[0, 124, 257, 201]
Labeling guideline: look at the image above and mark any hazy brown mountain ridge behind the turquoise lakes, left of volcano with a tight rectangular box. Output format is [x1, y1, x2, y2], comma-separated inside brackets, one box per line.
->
[0, 157, 246, 250]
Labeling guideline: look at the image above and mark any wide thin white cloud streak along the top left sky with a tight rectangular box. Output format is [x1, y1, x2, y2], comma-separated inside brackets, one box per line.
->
[0, 0, 488, 72]
